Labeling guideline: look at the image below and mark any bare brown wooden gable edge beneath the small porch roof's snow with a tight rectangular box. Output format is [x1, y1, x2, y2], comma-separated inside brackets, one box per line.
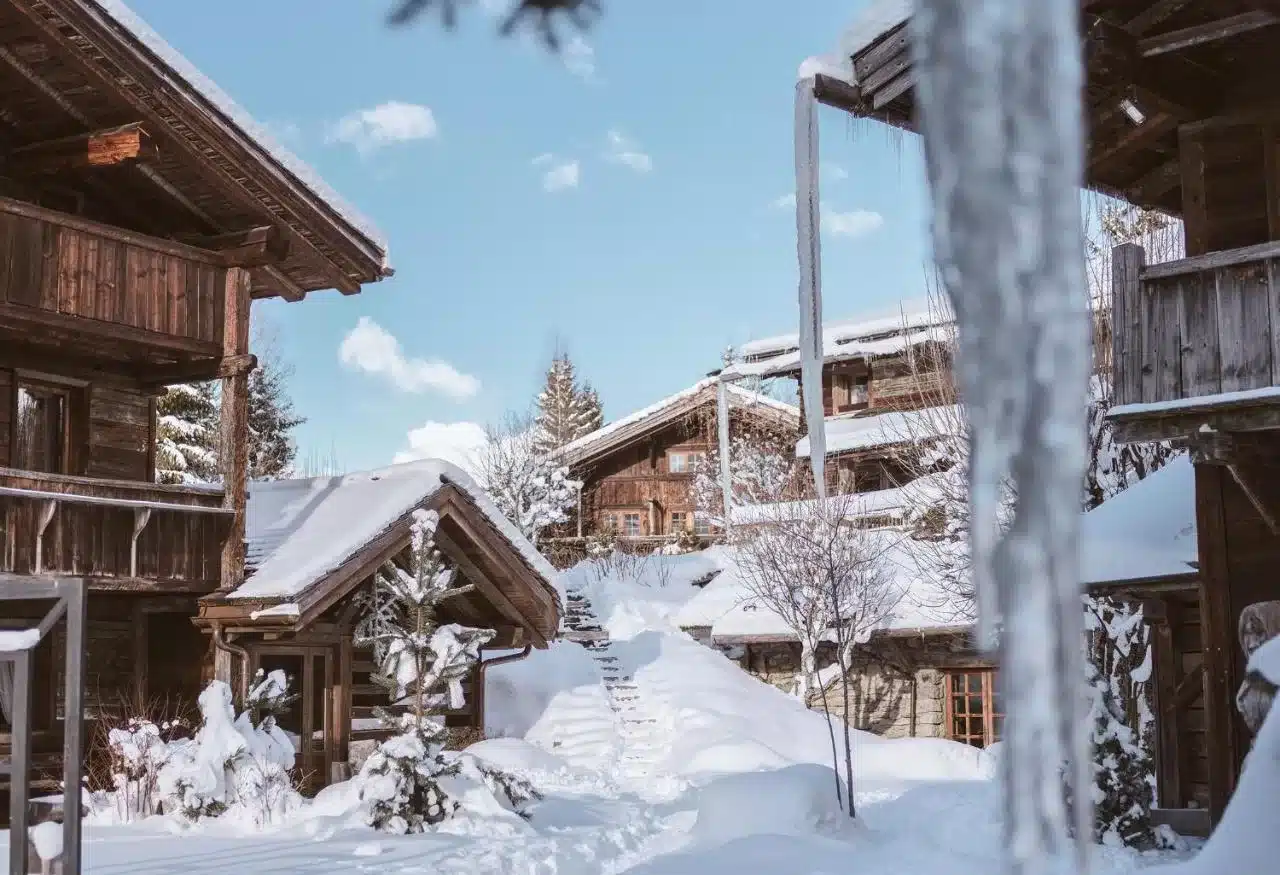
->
[198, 484, 559, 647]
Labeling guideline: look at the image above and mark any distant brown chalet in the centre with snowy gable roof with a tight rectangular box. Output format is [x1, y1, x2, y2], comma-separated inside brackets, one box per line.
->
[557, 377, 800, 544]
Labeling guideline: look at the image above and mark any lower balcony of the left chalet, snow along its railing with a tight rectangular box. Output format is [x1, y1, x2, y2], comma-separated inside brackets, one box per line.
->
[0, 468, 232, 594]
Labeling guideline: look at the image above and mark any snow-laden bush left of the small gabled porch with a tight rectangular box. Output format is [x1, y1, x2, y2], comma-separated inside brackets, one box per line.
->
[159, 672, 302, 826]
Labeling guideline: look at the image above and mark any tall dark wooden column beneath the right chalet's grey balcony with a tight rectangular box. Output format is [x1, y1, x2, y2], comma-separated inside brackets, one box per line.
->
[1196, 464, 1235, 823]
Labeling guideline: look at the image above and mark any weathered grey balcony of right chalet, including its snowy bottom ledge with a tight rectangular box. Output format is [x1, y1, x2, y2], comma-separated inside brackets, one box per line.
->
[1108, 242, 1280, 441]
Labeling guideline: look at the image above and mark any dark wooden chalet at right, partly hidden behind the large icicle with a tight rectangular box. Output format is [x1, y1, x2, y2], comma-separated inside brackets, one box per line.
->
[813, 0, 1280, 821]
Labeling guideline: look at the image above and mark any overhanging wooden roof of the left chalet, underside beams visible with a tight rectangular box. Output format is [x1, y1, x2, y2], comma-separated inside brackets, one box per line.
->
[0, 0, 390, 299]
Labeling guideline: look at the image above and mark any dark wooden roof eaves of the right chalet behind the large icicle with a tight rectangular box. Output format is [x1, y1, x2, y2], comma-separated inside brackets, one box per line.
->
[815, 0, 1280, 215]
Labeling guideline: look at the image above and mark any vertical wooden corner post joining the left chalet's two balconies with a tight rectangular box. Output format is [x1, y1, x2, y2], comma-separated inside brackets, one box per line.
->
[219, 267, 250, 592]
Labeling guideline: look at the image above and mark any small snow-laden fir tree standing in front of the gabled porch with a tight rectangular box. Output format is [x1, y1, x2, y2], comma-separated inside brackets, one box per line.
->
[357, 510, 536, 834]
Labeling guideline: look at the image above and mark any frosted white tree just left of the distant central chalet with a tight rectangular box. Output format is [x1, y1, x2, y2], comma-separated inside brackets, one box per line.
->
[476, 416, 581, 544]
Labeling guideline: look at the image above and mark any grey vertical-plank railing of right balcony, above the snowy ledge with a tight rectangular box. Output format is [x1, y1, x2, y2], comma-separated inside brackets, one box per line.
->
[1111, 242, 1280, 409]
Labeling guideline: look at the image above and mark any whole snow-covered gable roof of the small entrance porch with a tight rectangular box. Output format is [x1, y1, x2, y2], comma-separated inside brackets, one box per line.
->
[198, 461, 561, 647]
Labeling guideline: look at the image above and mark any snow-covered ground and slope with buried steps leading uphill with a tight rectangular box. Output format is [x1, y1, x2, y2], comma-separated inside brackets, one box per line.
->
[5, 554, 1192, 875]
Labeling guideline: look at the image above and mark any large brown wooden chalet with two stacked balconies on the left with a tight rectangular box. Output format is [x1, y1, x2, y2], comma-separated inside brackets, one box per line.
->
[0, 0, 554, 808]
